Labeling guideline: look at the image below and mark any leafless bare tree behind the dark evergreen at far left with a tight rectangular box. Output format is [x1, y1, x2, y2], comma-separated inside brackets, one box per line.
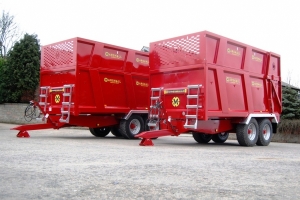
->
[0, 11, 20, 58]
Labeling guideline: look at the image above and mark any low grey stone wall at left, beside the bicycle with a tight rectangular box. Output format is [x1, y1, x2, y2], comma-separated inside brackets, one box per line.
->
[0, 103, 37, 124]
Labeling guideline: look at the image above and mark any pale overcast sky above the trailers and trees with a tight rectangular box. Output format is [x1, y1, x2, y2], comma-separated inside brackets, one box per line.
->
[0, 0, 300, 86]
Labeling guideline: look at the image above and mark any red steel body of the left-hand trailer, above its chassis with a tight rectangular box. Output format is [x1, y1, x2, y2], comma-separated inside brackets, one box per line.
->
[40, 38, 149, 116]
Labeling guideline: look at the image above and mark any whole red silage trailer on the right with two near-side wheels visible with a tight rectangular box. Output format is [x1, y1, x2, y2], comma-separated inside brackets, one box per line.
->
[136, 31, 282, 146]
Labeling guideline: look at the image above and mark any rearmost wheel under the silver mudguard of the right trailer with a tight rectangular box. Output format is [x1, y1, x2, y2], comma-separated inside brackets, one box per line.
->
[256, 119, 273, 146]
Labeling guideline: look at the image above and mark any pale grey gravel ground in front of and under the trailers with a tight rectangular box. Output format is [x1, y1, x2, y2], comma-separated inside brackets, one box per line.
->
[0, 123, 300, 200]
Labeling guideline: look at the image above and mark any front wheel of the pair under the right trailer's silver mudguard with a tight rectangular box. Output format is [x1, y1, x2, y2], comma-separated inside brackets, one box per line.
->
[236, 118, 259, 147]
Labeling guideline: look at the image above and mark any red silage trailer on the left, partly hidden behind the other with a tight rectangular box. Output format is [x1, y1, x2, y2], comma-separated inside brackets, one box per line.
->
[14, 38, 149, 138]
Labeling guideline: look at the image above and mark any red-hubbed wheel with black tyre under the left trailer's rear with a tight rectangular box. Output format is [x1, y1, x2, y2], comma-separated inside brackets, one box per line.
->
[120, 115, 144, 139]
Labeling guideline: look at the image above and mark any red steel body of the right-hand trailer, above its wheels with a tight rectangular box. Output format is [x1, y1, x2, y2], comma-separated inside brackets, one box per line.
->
[150, 31, 281, 133]
